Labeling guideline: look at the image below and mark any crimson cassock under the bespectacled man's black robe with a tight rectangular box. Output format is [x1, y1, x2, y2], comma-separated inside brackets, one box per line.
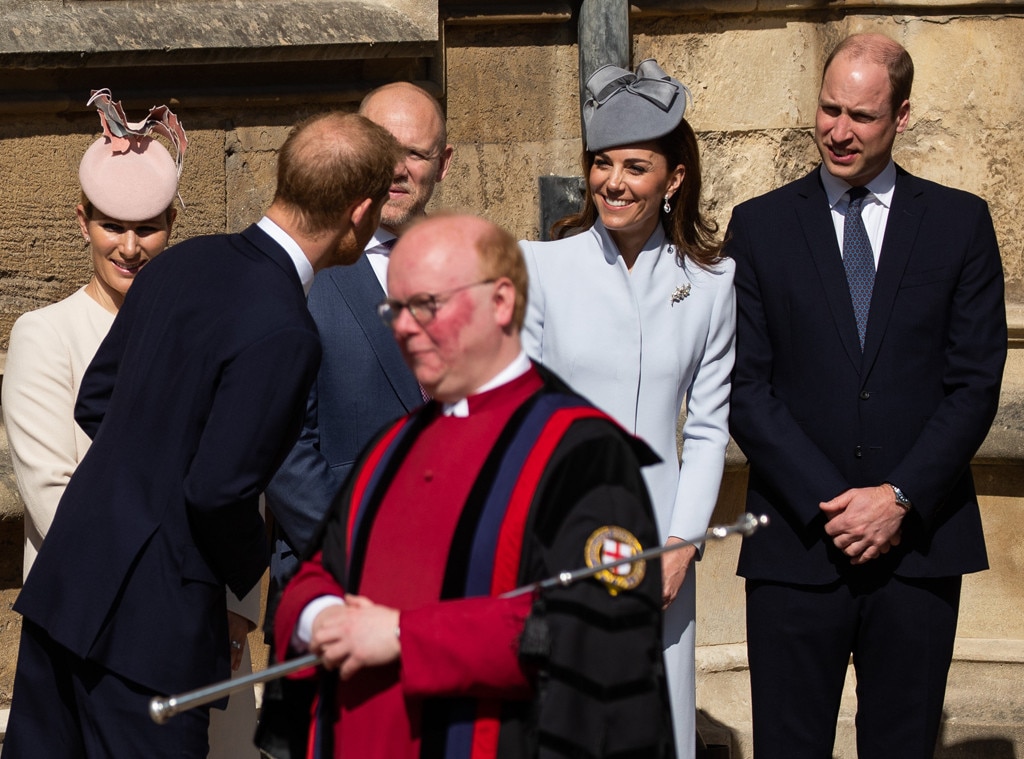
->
[276, 372, 541, 759]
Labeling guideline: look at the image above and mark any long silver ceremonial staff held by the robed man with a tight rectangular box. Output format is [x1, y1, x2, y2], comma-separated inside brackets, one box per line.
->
[150, 514, 768, 725]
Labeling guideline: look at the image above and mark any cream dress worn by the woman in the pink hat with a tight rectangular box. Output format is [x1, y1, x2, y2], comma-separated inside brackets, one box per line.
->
[2, 288, 260, 759]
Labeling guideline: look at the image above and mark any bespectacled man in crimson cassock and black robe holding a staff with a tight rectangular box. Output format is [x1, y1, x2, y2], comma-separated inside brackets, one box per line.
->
[275, 216, 674, 759]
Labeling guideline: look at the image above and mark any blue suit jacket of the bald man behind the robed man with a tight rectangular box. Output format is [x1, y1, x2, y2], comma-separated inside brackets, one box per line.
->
[266, 251, 423, 583]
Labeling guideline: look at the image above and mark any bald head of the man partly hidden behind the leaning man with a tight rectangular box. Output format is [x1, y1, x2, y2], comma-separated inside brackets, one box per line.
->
[359, 82, 453, 235]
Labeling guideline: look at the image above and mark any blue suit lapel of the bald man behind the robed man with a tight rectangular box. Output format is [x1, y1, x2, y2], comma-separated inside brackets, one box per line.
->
[324, 255, 423, 411]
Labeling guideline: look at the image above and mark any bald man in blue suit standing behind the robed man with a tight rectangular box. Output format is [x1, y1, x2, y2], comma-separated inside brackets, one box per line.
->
[266, 82, 453, 596]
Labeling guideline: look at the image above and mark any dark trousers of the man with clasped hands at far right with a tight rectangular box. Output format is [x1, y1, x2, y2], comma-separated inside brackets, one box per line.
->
[746, 577, 961, 759]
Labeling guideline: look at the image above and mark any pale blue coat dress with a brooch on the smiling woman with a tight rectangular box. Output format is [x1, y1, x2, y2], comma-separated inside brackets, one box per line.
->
[520, 220, 736, 759]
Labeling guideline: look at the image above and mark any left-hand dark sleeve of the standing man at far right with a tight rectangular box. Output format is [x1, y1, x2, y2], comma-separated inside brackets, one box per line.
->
[725, 207, 850, 525]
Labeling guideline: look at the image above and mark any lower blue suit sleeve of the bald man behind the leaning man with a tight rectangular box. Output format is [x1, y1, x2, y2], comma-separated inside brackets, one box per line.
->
[266, 383, 343, 556]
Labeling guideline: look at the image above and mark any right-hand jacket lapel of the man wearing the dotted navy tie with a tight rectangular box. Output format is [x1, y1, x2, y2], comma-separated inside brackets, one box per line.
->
[864, 167, 925, 376]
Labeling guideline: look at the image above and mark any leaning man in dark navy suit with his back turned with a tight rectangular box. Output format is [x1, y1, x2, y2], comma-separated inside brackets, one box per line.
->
[4, 114, 398, 759]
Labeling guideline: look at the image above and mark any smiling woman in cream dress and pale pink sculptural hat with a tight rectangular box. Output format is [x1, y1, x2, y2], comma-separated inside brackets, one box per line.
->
[2, 89, 259, 759]
